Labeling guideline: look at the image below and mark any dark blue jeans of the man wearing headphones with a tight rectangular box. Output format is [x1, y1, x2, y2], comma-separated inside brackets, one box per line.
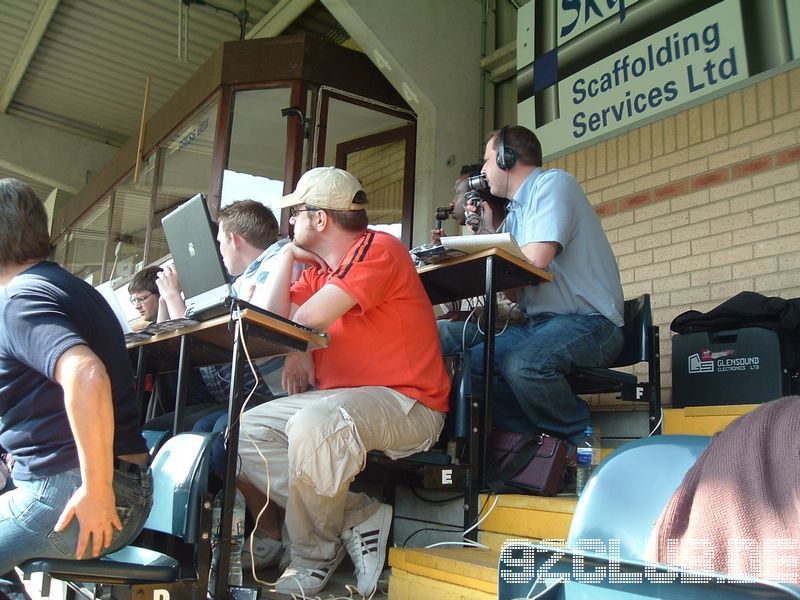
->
[438, 315, 623, 444]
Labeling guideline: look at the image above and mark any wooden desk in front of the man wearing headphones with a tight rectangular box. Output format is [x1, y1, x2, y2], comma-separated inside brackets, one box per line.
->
[417, 248, 553, 539]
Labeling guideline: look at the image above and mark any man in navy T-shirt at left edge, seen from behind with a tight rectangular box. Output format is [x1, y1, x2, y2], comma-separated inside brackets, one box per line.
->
[0, 179, 152, 594]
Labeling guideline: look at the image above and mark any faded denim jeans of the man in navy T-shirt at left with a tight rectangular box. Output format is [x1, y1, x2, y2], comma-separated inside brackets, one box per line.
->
[0, 467, 153, 577]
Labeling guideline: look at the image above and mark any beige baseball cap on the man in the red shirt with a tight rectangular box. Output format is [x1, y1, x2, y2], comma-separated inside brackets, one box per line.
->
[272, 167, 366, 210]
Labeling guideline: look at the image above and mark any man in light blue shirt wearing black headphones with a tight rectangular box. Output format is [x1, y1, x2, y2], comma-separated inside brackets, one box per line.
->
[439, 126, 623, 443]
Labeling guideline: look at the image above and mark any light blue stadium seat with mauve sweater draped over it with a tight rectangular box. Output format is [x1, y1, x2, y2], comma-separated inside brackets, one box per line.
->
[497, 435, 800, 600]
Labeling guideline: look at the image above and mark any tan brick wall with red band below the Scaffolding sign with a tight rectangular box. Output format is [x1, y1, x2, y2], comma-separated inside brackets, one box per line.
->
[545, 68, 800, 405]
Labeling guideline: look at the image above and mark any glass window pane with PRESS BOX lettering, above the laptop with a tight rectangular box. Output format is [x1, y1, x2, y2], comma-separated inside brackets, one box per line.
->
[146, 99, 219, 264]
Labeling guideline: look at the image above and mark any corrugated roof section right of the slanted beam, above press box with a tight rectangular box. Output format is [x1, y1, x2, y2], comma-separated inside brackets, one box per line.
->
[10, 0, 272, 144]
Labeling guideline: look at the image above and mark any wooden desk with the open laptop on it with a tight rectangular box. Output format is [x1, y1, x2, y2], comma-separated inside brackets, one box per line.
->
[128, 309, 328, 598]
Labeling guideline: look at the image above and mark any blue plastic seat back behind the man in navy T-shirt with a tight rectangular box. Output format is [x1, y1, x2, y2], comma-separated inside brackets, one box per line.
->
[144, 433, 212, 543]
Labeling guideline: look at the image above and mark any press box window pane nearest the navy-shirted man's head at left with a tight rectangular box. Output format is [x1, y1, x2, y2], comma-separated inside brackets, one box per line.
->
[62, 198, 110, 285]
